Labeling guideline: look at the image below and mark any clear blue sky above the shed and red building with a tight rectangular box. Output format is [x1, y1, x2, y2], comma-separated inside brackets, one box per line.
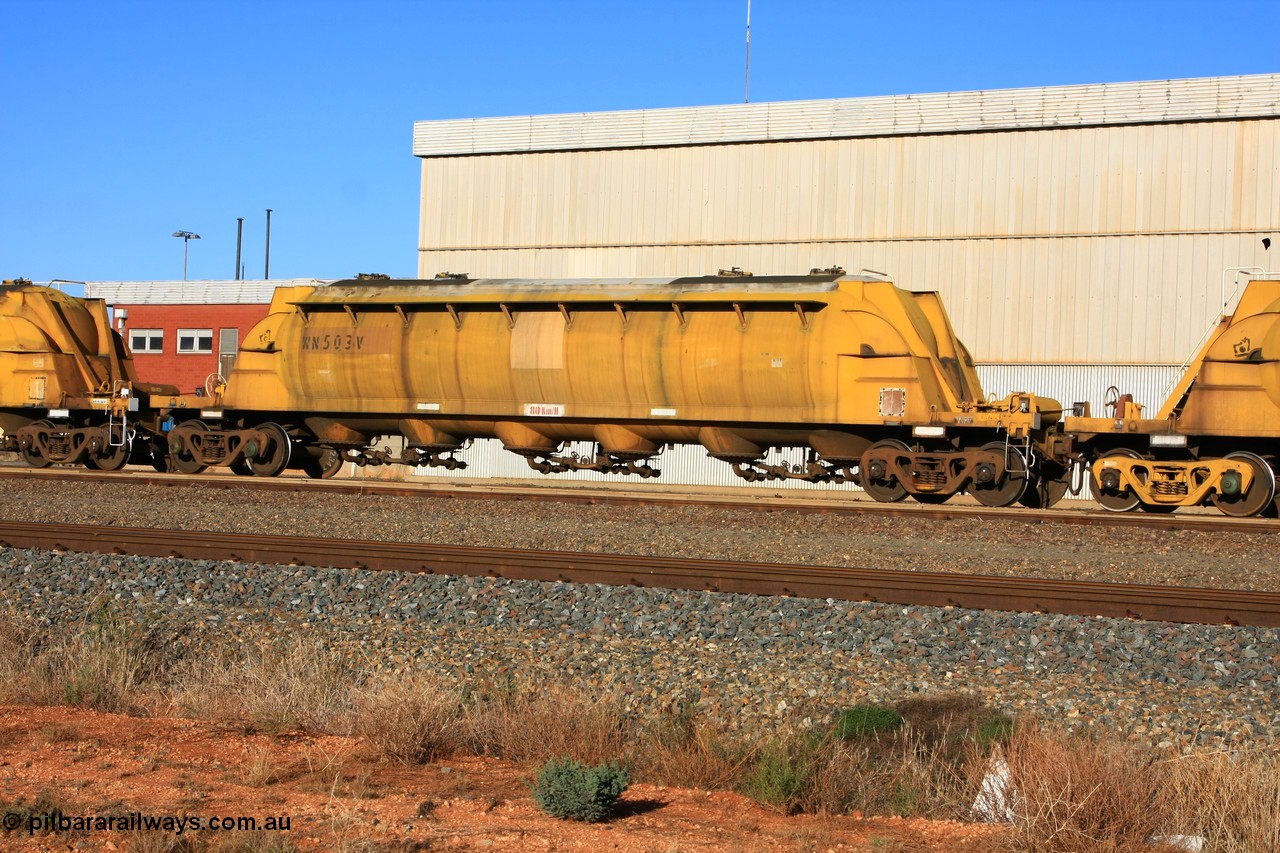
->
[0, 0, 1280, 280]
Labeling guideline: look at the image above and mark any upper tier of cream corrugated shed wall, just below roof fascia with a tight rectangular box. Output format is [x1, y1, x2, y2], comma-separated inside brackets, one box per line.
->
[421, 119, 1280, 251]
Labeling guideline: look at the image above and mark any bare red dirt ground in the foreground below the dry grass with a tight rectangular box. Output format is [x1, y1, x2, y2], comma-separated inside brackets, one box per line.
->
[0, 707, 997, 853]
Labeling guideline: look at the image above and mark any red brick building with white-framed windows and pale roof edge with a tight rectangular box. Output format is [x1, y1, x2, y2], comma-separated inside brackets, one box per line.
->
[84, 279, 321, 394]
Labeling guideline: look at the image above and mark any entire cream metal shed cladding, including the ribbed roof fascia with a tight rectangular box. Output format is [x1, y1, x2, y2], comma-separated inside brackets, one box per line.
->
[415, 74, 1280, 366]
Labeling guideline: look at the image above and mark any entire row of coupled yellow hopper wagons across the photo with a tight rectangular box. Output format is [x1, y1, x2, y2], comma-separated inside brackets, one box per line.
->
[0, 269, 1280, 515]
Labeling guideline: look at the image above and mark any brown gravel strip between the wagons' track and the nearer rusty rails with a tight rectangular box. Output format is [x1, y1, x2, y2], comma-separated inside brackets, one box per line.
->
[0, 478, 1280, 592]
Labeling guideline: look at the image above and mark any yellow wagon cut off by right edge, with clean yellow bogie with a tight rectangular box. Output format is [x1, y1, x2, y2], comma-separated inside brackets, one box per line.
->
[1066, 280, 1280, 516]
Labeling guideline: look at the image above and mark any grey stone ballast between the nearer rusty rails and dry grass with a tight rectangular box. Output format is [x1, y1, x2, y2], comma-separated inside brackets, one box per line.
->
[0, 548, 1280, 748]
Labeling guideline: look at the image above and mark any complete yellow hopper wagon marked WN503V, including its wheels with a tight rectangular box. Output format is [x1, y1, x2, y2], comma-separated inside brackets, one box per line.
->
[169, 270, 1066, 505]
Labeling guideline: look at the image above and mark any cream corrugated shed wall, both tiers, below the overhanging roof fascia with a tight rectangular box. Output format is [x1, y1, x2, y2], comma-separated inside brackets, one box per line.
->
[420, 119, 1280, 362]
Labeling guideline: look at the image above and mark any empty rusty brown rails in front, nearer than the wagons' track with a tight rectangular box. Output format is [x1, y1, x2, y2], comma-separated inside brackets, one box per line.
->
[0, 521, 1280, 628]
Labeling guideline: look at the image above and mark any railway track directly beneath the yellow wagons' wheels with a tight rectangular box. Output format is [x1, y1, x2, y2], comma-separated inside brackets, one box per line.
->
[0, 466, 1280, 534]
